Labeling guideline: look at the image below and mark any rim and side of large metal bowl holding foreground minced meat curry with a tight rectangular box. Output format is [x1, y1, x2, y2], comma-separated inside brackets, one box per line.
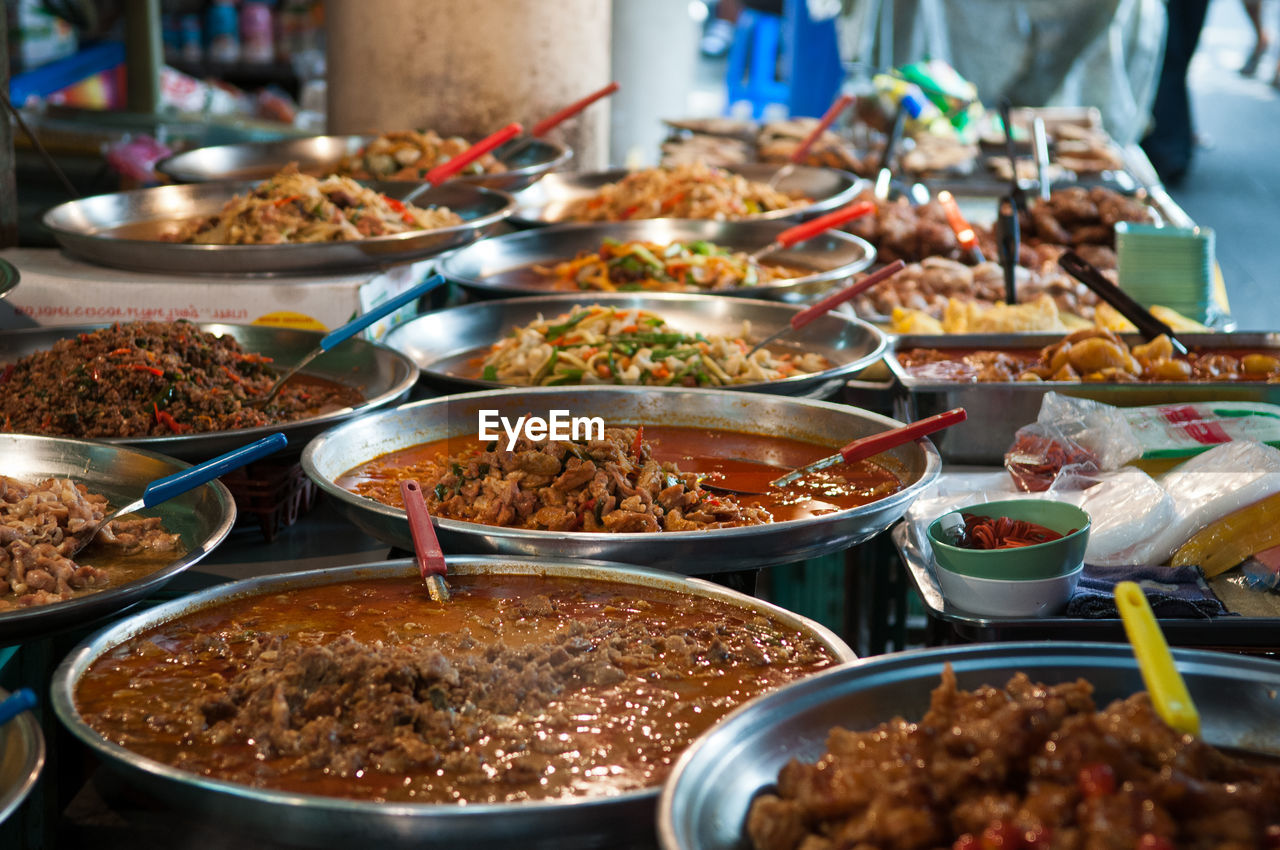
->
[51, 557, 854, 849]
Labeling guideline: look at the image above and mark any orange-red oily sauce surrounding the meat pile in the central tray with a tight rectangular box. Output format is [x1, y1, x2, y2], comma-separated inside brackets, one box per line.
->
[337, 425, 902, 530]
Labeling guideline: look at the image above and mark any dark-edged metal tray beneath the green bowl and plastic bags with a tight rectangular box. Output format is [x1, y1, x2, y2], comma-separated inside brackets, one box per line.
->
[890, 522, 1280, 653]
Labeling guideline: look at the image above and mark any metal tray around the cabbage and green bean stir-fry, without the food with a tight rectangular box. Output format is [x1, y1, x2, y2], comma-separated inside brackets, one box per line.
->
[376, 292, 888, 398]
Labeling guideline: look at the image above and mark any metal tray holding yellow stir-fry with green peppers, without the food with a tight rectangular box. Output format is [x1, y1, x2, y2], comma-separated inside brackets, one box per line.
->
[440, 219, 876, 301]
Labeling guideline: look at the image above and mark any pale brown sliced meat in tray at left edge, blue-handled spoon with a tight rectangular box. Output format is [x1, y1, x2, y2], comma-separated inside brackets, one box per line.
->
[0, 475, 182, 611]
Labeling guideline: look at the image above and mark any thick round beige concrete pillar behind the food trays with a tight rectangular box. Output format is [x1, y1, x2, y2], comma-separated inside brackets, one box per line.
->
[325, 0, 611, 170]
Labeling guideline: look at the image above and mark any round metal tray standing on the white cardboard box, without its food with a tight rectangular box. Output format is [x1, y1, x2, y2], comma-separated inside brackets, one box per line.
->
[44, 182, 515, 275]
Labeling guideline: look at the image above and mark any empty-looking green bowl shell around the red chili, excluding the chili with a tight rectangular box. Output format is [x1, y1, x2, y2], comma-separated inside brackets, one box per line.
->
[928, 499, 1089, 581]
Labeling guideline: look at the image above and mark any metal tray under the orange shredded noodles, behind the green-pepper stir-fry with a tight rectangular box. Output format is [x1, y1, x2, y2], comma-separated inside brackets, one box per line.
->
[511, 165, 865, 227]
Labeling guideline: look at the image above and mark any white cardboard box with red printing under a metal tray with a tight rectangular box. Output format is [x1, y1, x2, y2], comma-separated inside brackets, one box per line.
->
[0, 248, 433, 339]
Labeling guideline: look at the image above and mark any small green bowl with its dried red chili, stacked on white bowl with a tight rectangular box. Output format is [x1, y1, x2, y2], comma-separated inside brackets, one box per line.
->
[928, 499, 1089, 581]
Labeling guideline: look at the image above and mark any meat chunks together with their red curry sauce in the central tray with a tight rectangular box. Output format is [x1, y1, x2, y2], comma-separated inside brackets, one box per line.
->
[338, 425, 902, 533]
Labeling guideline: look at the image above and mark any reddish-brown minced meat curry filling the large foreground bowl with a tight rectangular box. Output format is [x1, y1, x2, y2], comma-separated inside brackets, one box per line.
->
[76, 573, 837, 803]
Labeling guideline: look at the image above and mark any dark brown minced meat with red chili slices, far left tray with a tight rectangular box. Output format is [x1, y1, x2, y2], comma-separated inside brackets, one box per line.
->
[0, 321, 364, 438]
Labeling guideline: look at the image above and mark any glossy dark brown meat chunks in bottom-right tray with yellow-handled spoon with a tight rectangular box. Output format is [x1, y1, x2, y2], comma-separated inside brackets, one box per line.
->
[746, 666, 1280, 850]
